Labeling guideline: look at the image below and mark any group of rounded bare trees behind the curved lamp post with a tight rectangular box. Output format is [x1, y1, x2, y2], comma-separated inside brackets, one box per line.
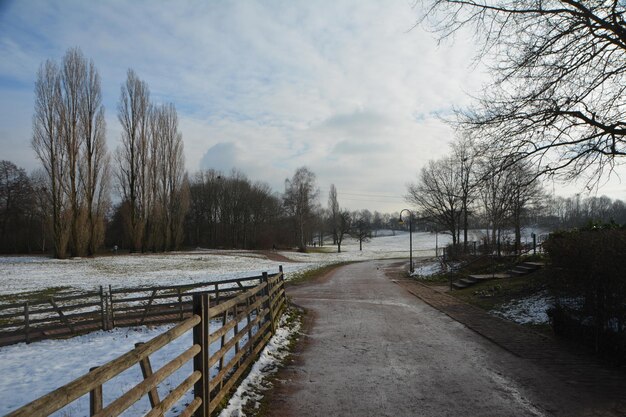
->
[407, 138, 544, 254]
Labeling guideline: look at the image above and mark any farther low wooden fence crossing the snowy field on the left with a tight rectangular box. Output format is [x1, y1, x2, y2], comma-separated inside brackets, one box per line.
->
[0, 266, 282, 346]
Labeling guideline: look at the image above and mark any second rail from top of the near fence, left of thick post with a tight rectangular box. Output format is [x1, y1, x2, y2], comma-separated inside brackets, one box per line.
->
[93, 345, 196, 417]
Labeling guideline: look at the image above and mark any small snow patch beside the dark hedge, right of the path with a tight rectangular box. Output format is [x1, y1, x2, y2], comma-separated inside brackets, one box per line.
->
[489, 291, 554, 324]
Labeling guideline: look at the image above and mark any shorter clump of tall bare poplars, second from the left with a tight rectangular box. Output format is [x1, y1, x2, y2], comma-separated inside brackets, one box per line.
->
[115, 70, 189, 251]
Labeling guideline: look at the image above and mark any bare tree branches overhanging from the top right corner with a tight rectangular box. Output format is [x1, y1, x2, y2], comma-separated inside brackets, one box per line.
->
[416, 0, 626, 185]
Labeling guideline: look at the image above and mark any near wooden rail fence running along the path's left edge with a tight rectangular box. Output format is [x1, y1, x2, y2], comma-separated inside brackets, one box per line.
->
[7, 272, 286, 417]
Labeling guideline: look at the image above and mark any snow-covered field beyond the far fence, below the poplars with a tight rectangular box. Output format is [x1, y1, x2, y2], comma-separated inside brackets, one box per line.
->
[0, 232, 450, 294]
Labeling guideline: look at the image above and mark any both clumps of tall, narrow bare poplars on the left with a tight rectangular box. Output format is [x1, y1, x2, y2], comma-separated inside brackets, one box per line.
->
[32, 48, 188, 258]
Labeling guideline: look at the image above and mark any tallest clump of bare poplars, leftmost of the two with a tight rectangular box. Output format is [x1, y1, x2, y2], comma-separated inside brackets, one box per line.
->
[32, 49, 109, 257]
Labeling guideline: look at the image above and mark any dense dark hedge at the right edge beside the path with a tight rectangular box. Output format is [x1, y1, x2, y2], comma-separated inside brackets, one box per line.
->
[544, 225, 626, 359]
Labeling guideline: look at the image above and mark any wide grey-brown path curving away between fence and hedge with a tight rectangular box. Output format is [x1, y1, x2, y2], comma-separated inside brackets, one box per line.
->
[268, 261, 619, 417]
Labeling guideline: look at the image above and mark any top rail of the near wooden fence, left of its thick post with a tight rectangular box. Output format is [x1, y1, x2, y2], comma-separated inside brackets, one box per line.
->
[7, 316, 200, 417]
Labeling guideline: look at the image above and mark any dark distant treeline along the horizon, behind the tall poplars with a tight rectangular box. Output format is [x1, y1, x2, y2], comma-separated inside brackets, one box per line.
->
[0, 154, 626, 254]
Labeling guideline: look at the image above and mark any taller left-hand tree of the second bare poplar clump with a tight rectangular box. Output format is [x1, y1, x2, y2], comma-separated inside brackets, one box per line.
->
[116, 70, 150, 251]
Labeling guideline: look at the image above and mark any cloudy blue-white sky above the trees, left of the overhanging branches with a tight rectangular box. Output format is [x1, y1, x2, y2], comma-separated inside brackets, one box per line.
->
[0, 0, 620, 212]
